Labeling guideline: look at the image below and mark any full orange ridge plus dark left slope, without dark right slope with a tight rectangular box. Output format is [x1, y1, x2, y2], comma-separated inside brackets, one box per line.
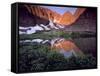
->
[19, 5, 85, 26]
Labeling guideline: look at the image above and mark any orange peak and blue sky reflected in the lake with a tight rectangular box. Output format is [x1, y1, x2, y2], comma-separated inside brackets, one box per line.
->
[51, 39, 83, 57]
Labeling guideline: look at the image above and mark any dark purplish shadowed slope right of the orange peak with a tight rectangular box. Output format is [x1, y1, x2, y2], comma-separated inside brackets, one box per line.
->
[66, 7, 97, 32]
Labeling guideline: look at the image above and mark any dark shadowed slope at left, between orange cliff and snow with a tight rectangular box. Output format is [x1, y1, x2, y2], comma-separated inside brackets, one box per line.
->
[18, 5, 49, 27]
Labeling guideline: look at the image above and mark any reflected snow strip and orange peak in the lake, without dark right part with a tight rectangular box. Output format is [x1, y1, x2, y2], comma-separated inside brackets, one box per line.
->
[20, 38, 83, 57]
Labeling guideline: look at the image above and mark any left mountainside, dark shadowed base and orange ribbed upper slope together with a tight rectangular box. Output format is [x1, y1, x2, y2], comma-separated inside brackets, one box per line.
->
[18, 5, 60, 27]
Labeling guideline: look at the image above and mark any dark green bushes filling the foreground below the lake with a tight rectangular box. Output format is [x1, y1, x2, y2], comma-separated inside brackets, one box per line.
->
[19, 44, 96, 72]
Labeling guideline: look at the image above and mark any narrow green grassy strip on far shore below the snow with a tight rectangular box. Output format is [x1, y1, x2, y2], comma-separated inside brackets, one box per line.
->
[20, 30, 95, 40]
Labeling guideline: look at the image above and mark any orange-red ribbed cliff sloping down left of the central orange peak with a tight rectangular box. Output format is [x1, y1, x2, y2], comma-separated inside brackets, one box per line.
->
[24, 5, 61, 21]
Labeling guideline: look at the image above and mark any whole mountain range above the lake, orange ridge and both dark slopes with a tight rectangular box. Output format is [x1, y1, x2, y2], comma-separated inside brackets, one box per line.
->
[19, 5, 97, 32]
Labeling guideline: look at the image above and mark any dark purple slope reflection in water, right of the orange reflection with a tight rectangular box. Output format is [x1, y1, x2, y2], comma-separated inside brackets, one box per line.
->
[73, 37, 97, 57]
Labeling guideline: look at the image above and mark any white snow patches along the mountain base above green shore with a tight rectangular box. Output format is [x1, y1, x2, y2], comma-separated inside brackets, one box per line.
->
[19, 20, 64, 34]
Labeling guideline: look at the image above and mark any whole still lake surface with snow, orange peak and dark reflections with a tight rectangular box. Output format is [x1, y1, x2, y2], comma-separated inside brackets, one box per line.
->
[20, 37, 96, 57]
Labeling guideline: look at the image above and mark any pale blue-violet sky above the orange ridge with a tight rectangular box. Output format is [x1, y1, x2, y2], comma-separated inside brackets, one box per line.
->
[41, 6, 77, 15]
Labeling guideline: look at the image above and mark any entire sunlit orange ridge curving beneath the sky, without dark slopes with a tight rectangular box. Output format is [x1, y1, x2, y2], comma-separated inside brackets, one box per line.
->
[24, 5, 85, 26]
